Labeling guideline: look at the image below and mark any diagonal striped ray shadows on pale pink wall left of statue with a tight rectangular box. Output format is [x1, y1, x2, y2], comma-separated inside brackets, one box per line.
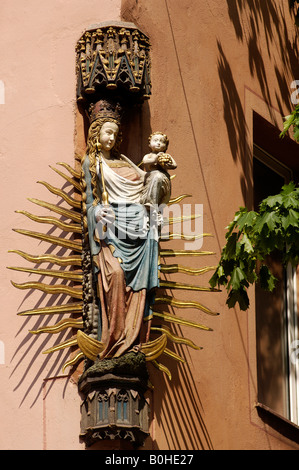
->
[10, 176, 79, 407]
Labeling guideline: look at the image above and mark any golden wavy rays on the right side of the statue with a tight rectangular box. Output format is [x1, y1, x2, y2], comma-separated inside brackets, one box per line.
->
[142, 194, 219, 380]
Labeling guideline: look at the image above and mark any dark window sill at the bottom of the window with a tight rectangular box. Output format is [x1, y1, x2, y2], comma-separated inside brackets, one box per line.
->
[255, 403, 299, 443]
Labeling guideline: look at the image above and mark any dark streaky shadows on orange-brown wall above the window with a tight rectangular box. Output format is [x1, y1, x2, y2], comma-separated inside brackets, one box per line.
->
[217, 0, 299, 202]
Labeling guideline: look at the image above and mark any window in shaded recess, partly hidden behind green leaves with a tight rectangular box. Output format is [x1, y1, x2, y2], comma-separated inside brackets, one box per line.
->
[253, 145, 299, 425]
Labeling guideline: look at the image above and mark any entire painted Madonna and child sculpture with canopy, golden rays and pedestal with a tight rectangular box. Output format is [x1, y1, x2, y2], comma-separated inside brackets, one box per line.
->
[10, 23, 220, 446]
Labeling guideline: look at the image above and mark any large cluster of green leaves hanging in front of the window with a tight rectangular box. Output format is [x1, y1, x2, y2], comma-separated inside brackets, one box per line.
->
[210, 183, 299, 310]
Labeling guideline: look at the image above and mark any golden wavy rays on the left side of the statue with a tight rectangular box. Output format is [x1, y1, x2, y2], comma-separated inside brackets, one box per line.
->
[8, 163, 84, 370]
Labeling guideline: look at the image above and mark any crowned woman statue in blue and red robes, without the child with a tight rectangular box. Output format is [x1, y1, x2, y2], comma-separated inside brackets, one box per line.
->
[82, 100, 169, 359]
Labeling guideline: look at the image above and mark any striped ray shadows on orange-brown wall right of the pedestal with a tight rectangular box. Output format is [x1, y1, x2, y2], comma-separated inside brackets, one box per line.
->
[149, 328, 213, 450]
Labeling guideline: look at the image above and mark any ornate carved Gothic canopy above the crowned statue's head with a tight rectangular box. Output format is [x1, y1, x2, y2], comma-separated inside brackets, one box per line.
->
[77, 23, 151, 102]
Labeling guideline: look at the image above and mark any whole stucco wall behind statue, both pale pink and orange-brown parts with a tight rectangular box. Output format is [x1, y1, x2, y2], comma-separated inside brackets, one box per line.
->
[0, 0, 299, 450]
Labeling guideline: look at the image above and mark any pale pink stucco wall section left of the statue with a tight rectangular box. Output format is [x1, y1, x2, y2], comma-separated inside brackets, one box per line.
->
[0, 0, 120, 449]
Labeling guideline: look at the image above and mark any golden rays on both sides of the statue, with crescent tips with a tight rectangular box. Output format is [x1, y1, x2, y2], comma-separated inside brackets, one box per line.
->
[8, 171, 218, 379]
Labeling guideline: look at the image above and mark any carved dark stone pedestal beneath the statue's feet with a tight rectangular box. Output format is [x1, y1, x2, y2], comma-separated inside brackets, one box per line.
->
[78, 353, 149, 447]
